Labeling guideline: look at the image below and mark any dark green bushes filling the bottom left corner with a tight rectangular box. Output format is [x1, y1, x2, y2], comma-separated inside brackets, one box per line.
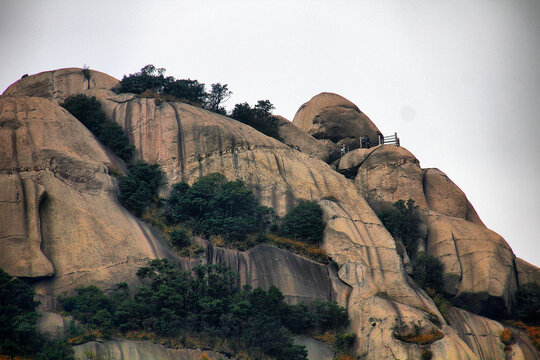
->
[0, 268, 73, 360]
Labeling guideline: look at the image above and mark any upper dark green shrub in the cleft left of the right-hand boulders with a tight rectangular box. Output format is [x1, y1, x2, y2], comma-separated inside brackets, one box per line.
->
[379, 199, 421, 258]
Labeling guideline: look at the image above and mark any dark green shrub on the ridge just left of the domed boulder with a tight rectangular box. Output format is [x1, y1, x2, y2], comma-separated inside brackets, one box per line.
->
[231, 100, 281, 141]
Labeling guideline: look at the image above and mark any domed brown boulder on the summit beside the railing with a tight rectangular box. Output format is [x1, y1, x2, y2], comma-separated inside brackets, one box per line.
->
[293, 93, 380, 149]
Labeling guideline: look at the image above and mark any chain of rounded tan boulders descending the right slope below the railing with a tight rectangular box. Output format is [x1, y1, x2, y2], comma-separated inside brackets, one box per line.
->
[352, 145, 517, 315]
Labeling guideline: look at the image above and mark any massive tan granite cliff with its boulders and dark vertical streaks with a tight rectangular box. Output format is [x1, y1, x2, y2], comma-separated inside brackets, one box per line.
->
[0, 69, 539, 359]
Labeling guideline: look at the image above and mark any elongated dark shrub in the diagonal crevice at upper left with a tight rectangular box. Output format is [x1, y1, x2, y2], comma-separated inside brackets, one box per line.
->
[60, 94, 135, 161]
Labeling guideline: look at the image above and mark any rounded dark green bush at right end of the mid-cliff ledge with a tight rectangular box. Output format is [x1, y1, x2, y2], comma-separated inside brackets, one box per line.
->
[280, 201, 324, 244]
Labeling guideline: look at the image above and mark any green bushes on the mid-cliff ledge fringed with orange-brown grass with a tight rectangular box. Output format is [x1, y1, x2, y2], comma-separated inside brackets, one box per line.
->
[162, 173, 329, 263]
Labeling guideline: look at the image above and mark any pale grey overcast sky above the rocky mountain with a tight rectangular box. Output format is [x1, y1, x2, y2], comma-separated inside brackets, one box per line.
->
[0, 0, 540, 266]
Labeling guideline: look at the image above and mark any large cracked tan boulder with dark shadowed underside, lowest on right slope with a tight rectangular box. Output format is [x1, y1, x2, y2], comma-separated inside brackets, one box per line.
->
[424, 212, 517, 316]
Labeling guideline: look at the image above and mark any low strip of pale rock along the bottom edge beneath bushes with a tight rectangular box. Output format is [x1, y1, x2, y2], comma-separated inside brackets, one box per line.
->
[73, 340, 229, 360]
